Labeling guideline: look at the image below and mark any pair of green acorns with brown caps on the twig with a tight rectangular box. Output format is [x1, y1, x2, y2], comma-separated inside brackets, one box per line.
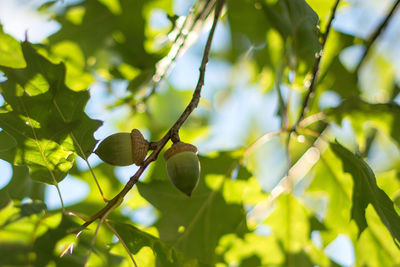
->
[94, 129, 200, 197]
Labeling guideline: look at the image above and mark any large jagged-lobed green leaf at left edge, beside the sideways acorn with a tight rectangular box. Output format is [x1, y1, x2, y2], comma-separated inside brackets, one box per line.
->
[0, 42, 101, 184]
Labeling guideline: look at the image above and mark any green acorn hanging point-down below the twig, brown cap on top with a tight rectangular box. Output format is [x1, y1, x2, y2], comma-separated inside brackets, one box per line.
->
[164, 142, 200, 197]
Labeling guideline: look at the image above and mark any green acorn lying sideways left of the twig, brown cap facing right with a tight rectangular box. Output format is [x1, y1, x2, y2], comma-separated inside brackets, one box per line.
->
[94, 129, 149, 166]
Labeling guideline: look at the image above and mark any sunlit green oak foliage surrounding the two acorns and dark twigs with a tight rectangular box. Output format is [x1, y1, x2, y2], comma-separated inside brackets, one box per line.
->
[0, 0, 400, 267]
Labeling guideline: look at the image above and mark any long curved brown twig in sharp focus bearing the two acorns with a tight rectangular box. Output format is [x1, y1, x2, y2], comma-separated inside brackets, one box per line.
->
[82, 0, 224, 228]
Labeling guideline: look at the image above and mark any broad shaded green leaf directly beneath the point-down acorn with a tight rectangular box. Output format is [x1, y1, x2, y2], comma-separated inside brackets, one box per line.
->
[138, 180, 245, 265]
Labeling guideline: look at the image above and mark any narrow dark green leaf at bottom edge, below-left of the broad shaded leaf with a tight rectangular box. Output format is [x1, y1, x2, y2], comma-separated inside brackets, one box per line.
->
[110, 222, 198, 267]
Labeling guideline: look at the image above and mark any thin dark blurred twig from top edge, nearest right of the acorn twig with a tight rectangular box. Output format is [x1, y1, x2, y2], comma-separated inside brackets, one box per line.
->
[293, 0, 340, 126]
